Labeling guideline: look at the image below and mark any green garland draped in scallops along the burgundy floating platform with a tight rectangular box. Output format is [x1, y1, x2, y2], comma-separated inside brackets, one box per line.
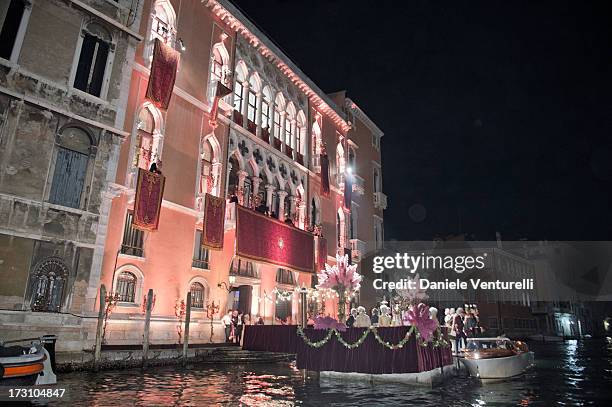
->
[297, 326, 448, 350]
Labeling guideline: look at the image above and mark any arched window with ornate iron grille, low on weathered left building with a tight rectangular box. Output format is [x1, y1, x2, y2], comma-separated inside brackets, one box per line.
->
[30, 257, 69, 312]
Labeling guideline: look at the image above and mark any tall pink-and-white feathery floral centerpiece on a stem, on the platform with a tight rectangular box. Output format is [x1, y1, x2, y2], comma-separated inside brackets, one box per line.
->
[317, 255, 361, 323]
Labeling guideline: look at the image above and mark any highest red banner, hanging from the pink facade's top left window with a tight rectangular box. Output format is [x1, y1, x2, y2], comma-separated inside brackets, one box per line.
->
[146, 38, 180, 110]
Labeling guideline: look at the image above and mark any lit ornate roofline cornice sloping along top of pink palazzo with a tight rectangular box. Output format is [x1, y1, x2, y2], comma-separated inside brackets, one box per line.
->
[202, 0, 350, 132]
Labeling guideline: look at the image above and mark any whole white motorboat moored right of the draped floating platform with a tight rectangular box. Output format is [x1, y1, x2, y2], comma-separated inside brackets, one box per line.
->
[461, 337, 534, 379]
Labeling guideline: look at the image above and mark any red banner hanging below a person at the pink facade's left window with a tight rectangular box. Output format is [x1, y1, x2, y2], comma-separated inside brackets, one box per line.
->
[132, 168, 166, 231]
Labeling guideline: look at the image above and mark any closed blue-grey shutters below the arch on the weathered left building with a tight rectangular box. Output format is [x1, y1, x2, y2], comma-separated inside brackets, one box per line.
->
[49, 147, 89, 208]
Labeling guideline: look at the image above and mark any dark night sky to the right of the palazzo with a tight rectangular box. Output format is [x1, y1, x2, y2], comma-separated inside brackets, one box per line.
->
[234, 0, 612, 240]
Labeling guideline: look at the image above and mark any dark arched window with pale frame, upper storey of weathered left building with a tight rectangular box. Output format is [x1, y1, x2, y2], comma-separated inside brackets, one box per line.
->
[72, 22, 115, 98]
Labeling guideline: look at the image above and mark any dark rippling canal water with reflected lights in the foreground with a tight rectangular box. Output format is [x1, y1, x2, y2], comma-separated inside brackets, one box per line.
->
[44, 340, 612, 407]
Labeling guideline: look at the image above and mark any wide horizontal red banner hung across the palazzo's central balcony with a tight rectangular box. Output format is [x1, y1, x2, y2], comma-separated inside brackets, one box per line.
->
[236, 205, 314, 273]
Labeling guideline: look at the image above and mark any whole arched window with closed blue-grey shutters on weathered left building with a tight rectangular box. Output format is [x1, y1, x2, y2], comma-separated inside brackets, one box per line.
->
[49, 127, 95, 208]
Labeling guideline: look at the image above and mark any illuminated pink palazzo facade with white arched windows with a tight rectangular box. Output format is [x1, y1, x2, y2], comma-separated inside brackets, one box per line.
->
[101, 0, 387, 344]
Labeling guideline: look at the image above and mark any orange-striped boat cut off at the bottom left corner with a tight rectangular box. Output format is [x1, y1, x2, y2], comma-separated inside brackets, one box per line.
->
[0, 335, 57, 386]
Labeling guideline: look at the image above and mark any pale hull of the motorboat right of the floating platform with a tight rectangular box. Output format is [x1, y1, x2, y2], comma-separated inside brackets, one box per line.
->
[461, 352, 534, 379]
